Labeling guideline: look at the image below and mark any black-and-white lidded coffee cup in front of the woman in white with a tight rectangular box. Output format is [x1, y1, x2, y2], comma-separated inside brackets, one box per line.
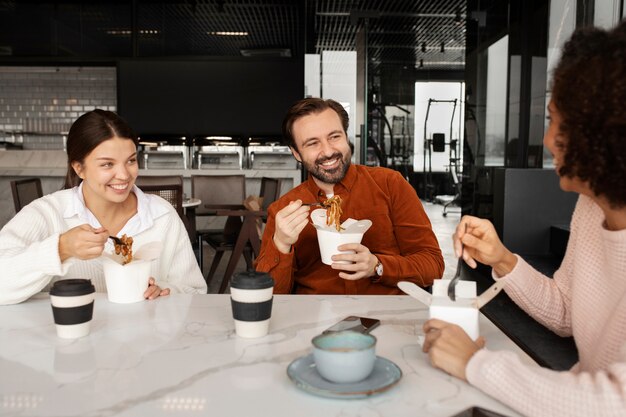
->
[50, 279, 96, 339]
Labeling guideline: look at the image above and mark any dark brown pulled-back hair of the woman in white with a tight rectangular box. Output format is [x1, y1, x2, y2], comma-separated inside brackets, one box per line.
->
[64, 109, 138, 188]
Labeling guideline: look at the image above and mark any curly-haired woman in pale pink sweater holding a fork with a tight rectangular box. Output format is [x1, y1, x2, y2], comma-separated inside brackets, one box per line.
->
[423, 21, 626, 417]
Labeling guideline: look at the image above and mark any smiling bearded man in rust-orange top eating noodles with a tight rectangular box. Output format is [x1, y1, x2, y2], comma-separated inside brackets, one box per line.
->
[256, 98, 444, 294]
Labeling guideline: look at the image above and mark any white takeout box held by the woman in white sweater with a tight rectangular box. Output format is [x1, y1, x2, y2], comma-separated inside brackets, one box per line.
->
[102, 257, 151, 304]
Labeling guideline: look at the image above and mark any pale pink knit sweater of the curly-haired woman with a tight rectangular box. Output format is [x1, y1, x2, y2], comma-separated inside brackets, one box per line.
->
[466, 196, 626, 417]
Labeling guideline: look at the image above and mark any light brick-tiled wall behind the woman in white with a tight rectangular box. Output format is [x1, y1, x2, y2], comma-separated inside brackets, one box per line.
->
[0, 67, 117, 149]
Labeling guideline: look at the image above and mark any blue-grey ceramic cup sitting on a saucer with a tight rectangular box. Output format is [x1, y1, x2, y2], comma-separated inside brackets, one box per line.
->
[311, 330, 376, 384]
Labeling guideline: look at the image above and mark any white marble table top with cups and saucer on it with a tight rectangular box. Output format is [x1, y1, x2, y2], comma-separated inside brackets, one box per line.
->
[0, 294, 530, 417]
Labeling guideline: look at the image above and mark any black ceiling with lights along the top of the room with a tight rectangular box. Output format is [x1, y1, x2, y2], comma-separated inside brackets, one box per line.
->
[0, 0, 467, 73]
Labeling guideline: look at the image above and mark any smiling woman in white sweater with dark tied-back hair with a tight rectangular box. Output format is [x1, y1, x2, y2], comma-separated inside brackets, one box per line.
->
[0, 110, 206, 304]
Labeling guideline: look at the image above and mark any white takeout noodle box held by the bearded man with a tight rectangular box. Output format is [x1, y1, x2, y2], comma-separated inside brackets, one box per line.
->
[311, 209, 372, 265]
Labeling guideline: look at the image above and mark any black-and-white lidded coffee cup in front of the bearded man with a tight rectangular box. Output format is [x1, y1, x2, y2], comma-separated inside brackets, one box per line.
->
[230, 271, 274, 338]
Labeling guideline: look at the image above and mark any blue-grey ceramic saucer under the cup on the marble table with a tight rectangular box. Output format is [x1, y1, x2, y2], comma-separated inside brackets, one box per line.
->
[287, 354, 402, 398]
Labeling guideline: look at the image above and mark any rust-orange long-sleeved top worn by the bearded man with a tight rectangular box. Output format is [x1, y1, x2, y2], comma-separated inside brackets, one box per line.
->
[251, 165, 444, 294]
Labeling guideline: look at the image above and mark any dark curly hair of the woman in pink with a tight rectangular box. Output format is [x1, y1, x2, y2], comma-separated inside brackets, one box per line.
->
[552, 20, 626, 208]
